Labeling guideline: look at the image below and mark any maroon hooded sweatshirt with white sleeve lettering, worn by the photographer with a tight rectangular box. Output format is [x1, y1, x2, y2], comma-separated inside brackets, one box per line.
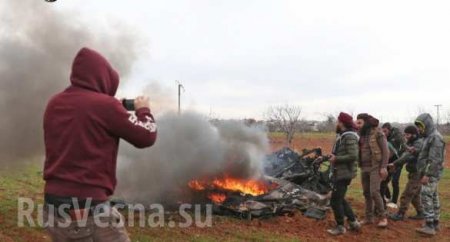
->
[44, 48, 156, 201]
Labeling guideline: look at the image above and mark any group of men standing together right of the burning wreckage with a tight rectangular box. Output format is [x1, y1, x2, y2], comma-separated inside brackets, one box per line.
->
[328, 113, 445, 236]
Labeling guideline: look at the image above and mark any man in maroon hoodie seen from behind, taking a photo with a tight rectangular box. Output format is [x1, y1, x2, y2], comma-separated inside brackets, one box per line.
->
[44, 48, 156, 241]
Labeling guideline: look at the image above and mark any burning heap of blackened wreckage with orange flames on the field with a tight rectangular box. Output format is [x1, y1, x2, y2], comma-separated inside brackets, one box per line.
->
[188, 148, 331, 219]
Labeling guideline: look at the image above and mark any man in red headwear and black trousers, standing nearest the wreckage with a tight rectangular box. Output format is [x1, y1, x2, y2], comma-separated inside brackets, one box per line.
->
[328, 113, 361, 235]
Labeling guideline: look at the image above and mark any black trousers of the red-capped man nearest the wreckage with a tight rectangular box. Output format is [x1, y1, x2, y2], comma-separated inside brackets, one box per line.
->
[330, 180, 356, 225]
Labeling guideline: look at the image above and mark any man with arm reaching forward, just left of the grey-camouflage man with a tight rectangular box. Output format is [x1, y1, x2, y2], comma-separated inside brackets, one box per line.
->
[388, 125, 424, 221]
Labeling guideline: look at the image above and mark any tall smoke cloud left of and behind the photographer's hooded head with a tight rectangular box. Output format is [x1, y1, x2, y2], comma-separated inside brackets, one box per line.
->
[0, 0, 139, 167]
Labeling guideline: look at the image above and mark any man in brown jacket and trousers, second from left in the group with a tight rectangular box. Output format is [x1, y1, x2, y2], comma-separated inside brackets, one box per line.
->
[356, 113, 389, 228]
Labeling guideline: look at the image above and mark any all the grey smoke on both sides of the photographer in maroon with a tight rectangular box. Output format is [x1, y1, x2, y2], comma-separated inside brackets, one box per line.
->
[0, 0, 267, 202]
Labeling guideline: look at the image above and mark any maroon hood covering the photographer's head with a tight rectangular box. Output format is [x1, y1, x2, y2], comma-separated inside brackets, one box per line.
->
[70, 48, 119, 96]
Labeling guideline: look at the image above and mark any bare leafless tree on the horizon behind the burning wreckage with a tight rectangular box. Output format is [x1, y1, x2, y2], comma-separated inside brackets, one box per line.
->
[265, 104, 302, 145]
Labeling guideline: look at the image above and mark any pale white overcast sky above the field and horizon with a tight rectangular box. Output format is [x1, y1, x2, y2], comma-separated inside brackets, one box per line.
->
[52, 0, 450, 121]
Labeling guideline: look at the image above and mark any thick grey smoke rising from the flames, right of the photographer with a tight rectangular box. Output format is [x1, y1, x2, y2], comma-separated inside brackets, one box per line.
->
[117, 112, 268, 203]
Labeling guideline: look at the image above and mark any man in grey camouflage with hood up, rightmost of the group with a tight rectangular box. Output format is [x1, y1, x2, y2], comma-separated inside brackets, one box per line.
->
[414, 113, 445, 235]
